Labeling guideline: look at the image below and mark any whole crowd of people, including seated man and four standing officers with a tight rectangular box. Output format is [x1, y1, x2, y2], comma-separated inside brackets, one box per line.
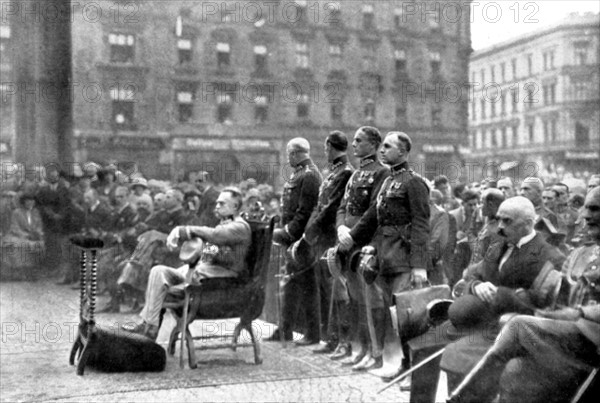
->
[2, 126, 600, 401]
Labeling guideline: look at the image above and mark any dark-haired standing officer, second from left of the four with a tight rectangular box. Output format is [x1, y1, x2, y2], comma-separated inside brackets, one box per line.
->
[304, 131, 354, 354]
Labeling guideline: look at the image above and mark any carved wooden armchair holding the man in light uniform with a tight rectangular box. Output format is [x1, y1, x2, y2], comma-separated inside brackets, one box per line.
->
[163, 217, 279, 369]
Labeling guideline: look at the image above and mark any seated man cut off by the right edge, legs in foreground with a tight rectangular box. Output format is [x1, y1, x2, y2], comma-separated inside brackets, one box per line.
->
[451, 189, 600, 403]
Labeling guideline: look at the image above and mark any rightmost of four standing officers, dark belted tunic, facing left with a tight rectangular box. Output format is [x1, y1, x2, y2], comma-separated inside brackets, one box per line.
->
[350, 132, 430, 375]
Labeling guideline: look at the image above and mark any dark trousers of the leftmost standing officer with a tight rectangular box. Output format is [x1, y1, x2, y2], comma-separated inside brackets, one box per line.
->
[281, 262, 321, 339]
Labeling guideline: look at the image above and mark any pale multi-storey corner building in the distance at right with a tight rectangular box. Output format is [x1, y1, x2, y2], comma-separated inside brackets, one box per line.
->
[469, 13, 600, 175]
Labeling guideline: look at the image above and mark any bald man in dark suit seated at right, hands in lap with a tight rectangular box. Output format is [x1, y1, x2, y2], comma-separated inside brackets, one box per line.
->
[440, 196, 565, 398]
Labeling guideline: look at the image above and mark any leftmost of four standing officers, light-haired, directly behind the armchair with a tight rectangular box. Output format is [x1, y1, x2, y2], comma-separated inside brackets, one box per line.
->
[270, 137, 322, 345]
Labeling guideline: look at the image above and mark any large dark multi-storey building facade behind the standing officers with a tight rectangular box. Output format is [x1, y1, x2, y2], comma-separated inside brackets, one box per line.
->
[5, 0, 471, 185]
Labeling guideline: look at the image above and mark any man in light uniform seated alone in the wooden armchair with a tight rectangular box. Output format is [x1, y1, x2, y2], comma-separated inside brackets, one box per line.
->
[123, 188, 252, 340]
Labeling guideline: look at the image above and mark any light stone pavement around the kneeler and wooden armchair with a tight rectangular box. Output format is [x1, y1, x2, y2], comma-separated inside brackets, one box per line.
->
[0, 280, 420, 402]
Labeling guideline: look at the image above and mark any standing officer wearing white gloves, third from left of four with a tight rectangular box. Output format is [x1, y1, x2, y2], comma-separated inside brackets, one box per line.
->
[330, 126, 389, 370]
